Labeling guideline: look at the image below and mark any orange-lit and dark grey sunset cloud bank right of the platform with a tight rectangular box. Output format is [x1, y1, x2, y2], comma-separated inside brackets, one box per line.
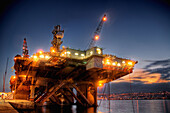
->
[113, 59, 170, 84]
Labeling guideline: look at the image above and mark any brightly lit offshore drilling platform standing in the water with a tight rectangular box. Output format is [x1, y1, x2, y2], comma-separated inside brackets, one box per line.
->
[10, 15, 137, 107]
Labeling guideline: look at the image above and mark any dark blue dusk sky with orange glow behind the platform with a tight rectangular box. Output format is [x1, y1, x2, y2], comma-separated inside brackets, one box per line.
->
[0, 0, 170, 92]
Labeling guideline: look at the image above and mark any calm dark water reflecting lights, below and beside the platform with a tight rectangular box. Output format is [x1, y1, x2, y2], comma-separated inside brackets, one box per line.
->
[20, 100, 170, 113]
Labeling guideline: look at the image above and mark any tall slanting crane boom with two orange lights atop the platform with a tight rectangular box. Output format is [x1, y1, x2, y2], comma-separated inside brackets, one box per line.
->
[88, 14, 107, 49]
